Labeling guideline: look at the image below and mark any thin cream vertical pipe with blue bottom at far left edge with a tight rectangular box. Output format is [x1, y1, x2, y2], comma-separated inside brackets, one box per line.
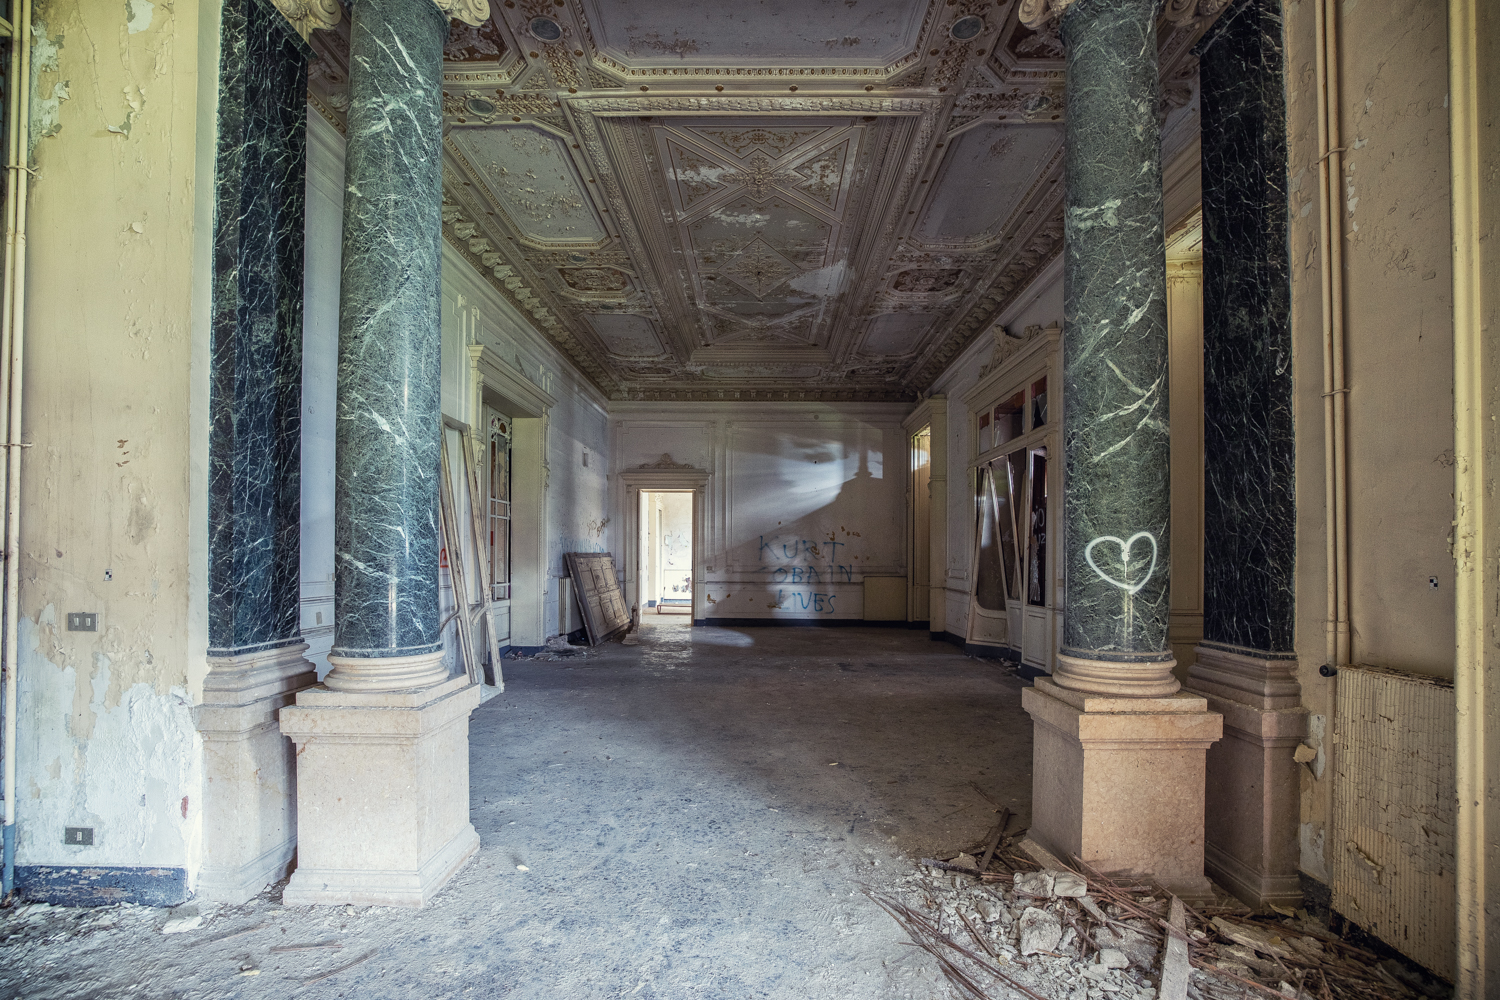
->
[0, 0, 32, 895]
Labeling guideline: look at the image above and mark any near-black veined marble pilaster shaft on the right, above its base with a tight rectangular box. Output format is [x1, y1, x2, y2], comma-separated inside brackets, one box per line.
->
[1199, 0, 1296, 652]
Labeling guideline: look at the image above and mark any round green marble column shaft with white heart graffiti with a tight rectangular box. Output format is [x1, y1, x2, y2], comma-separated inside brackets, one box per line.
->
[1058, 0, 1176, 696]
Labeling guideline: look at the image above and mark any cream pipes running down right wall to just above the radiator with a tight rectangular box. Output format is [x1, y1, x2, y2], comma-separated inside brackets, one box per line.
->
[1317, 0, 1352, 676]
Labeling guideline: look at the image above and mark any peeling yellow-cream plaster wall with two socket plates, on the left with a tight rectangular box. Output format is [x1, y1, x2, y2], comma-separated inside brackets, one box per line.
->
[17, 0, 218, 873]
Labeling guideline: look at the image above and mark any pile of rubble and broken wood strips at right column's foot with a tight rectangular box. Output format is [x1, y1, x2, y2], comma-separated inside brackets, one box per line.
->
[867, 816, 1452, 1000]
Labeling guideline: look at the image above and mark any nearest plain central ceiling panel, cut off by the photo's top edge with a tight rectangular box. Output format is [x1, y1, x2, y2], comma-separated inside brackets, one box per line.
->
[584, 0, 927, 69]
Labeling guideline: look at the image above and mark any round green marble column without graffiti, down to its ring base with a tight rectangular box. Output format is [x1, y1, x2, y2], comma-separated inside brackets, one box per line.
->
[337, 0, 449, 690]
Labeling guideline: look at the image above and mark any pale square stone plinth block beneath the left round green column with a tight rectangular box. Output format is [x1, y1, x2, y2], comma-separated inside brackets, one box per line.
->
[281, 676, 479, 906]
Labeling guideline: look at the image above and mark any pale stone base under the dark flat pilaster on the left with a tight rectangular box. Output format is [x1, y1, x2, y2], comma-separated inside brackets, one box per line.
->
[194, 642, 318, 903]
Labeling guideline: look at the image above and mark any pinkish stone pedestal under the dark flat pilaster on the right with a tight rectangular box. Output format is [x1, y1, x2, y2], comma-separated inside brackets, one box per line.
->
[1187, 643, 1308, 907]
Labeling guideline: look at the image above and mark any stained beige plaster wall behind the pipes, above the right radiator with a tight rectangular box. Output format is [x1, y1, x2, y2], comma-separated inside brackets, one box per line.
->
[1286, 0, 1455, 882]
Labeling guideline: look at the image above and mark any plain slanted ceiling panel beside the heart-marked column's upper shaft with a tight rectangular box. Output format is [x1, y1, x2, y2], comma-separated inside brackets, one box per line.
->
[914, 123, 1064, 249]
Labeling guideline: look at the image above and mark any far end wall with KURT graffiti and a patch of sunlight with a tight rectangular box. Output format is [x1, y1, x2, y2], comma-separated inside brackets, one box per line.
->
[611, 402, 911, 619]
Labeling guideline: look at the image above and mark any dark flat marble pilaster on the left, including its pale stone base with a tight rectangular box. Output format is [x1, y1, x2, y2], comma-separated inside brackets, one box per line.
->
[194, 0, 317, 903]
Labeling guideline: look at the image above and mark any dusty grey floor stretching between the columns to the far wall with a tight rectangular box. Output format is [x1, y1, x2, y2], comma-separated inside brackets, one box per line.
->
[0, 618, 1031, 1000]
